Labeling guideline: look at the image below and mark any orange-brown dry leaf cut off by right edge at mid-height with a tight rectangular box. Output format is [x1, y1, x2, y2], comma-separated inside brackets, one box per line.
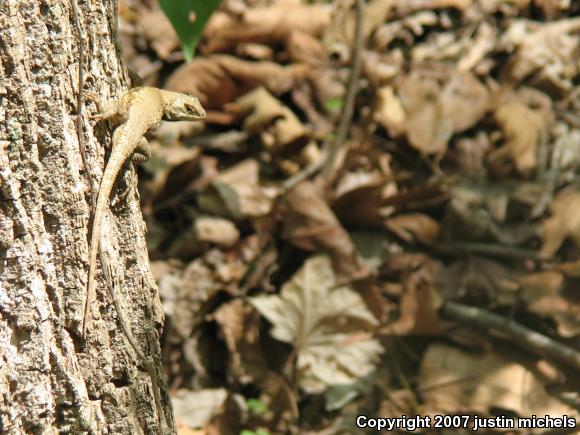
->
[541, 188, 580, 256]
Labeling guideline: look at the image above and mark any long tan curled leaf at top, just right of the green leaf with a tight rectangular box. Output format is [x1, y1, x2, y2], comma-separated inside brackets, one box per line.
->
[200, 2, 331, 53]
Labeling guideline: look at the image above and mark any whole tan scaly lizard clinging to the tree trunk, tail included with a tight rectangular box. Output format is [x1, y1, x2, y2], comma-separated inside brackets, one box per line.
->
[82, 87, 205, 339]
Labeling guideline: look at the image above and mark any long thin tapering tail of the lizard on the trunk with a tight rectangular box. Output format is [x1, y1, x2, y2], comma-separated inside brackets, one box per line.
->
[82, 153, 125, 340]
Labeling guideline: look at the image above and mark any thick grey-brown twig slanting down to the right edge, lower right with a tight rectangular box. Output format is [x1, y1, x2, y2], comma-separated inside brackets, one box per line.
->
[441, 302, 580, 371]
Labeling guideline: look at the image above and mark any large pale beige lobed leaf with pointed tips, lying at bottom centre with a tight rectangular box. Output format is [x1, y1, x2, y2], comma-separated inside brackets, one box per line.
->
[250, 256, 383, 393]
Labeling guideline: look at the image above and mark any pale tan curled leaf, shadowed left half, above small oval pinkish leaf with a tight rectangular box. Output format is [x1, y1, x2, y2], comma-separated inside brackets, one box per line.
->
[198, 159, 272, 219]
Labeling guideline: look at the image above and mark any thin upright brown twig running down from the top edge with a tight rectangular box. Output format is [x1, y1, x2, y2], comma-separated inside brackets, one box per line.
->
[321, 0, 365, 184]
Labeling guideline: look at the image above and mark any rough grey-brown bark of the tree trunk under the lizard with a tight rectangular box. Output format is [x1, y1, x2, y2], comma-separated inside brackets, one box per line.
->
[0, 0, 174, 434]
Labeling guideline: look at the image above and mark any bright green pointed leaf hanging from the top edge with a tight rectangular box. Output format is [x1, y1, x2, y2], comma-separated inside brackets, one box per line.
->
[159, 0, 221, 62]
